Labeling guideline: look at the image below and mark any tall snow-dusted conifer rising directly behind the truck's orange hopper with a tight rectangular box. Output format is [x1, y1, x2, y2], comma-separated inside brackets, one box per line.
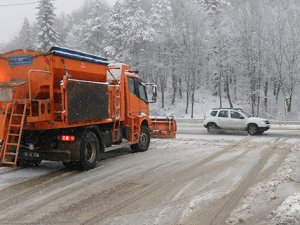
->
[36, 0, 59, 51]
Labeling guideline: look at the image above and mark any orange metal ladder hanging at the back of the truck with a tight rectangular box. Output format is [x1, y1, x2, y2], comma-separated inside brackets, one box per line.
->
[0, 102, 28, 166]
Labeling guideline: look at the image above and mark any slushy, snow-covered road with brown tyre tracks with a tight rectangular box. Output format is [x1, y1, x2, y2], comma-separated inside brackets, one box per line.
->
[0, 124, 300, 225]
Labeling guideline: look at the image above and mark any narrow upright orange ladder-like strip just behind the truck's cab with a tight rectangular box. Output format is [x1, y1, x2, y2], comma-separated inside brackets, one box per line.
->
[112, 86, 121, 143]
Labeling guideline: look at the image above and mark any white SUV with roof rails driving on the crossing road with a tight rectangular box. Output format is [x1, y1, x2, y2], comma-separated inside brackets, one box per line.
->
[203, 108, 271, 135]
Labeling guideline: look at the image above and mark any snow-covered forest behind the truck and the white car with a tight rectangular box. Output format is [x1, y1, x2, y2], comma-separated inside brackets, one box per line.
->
[0, 0, 300, 120]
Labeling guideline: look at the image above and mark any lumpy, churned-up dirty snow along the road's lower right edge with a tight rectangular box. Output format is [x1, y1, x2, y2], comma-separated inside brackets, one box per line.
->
[226, 139, 300, 225]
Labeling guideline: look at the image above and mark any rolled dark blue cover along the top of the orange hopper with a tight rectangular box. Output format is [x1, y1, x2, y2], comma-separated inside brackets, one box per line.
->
[49, 46, 109, 66]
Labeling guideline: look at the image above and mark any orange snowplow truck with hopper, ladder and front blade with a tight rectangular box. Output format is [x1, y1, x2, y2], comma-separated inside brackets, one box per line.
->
[0, 47, 176, 170]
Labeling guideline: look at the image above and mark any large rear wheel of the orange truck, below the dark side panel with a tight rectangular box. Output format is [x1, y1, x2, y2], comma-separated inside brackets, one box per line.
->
[79, 131, 99, 170]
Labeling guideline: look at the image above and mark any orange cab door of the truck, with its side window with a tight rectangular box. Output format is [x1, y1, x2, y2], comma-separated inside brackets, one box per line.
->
[126, 76, 149, 117]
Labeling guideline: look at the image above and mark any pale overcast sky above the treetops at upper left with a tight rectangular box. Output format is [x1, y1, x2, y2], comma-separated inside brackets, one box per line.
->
[0, 0, 116, 43]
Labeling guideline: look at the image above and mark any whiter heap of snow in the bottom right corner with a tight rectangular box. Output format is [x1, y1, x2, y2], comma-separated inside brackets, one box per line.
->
[270, 193, 300, 225]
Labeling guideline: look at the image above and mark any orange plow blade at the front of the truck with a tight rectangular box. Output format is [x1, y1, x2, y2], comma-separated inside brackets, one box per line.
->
[150, 116, 177, 138]
